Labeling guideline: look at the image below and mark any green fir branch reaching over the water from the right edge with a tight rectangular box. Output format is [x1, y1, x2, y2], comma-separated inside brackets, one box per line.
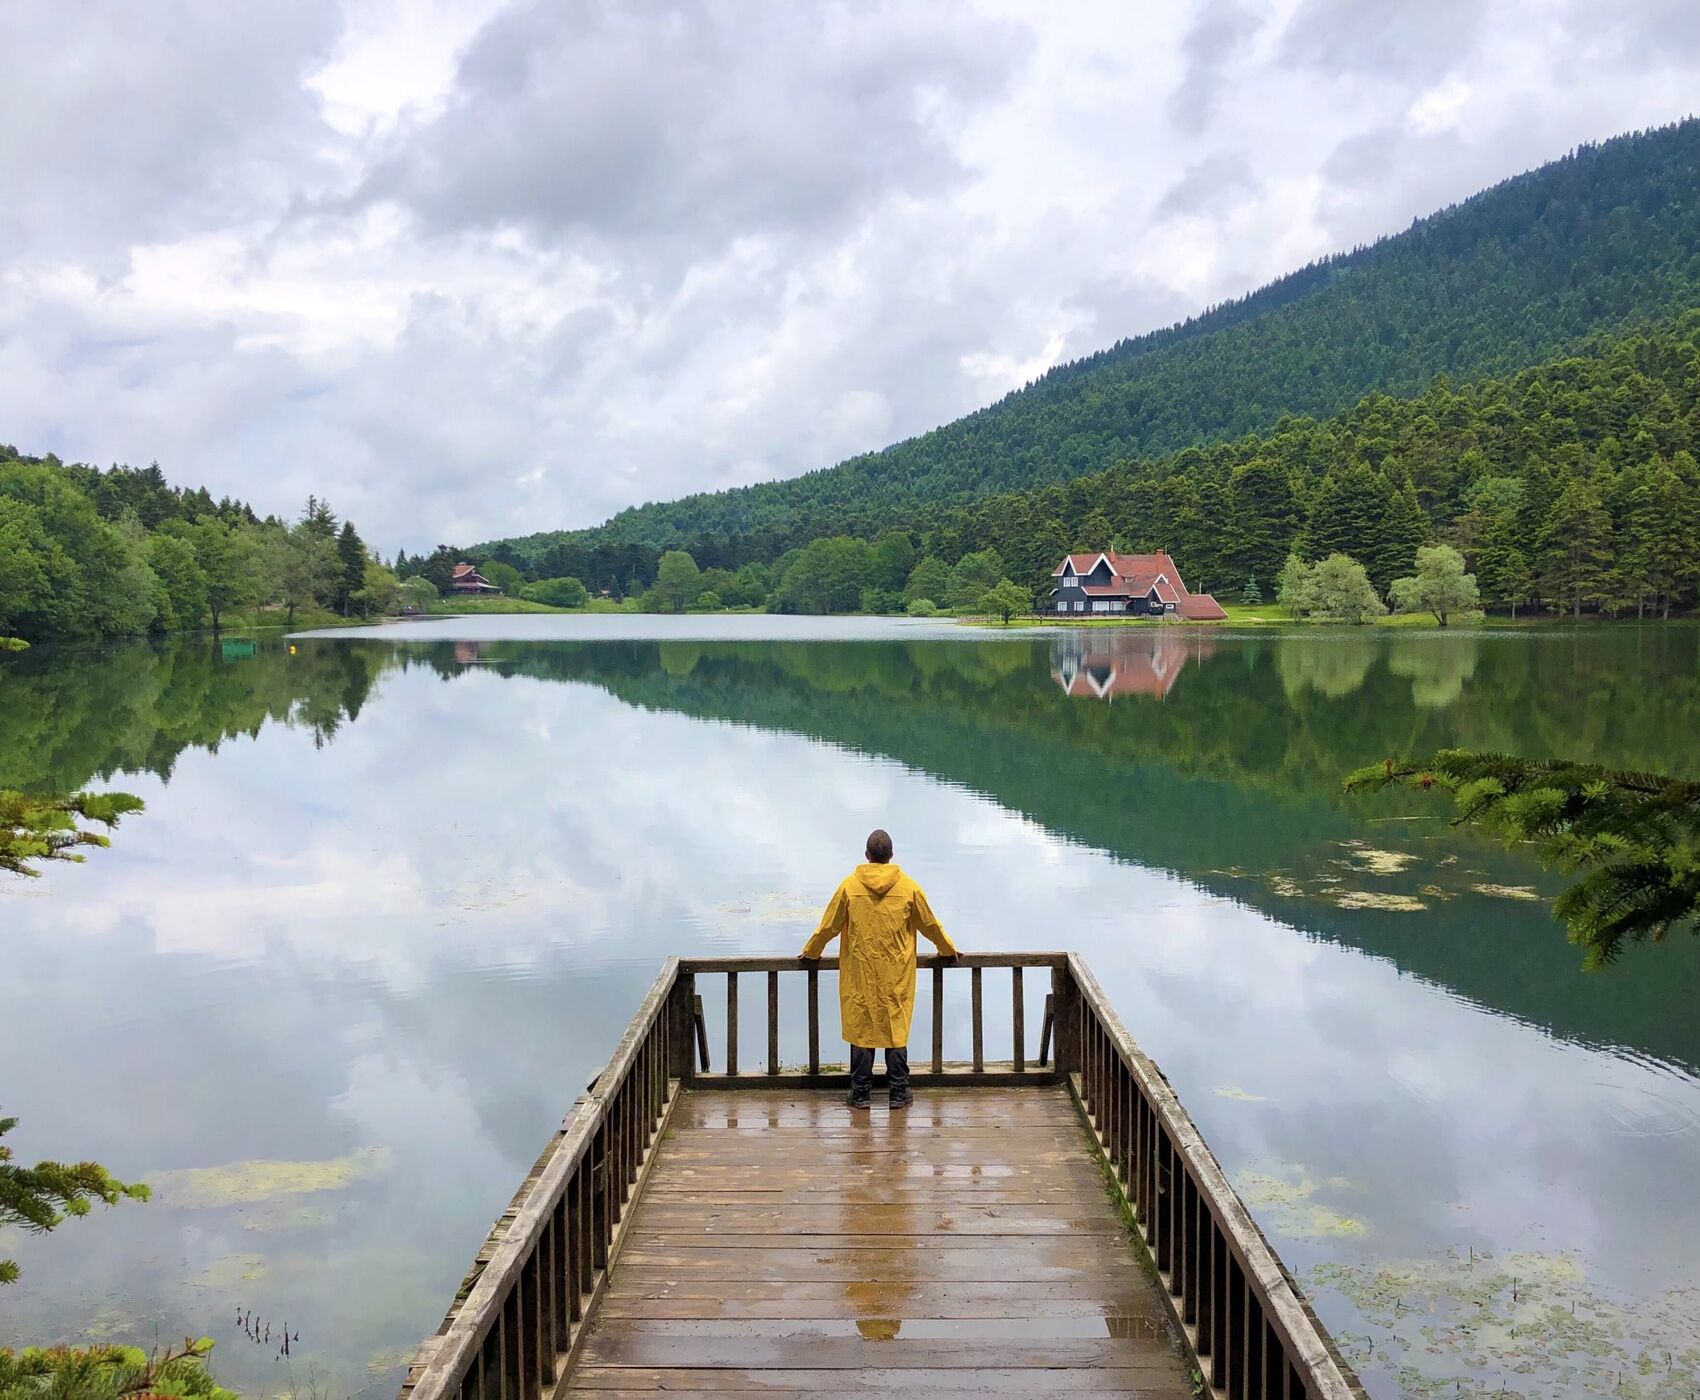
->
[1345, 749, 1700, 968]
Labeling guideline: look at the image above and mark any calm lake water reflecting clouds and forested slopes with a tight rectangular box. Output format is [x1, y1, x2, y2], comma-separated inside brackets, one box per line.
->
[0, 618, 1700, 1397]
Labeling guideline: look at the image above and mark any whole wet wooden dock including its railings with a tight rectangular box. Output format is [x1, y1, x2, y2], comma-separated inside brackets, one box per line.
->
[401, 953, 1362, 1400]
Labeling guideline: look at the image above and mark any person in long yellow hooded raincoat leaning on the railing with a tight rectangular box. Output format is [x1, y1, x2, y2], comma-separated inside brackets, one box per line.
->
[802, 831, 962, 1108]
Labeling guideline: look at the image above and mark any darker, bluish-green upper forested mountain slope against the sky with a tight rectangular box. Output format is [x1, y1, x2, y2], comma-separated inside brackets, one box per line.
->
[474, 121, 1700, 573]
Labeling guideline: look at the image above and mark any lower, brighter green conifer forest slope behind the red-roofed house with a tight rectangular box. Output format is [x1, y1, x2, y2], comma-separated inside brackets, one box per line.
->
[476, 311, 1700, 613]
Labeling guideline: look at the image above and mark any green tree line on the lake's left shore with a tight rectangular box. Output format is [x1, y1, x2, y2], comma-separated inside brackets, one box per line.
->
[0, 445, 400, 641]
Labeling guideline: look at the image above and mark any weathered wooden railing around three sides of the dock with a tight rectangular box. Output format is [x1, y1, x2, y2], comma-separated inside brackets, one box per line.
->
[401, 953, 1363, 1400]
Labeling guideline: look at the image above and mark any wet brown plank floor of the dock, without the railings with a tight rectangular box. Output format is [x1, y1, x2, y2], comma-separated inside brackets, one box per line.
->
[570, 1087, 1192, 1400]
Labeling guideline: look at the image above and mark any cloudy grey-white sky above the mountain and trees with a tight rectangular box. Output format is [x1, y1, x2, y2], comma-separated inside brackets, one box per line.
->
[0, 0, 1700, 554]
